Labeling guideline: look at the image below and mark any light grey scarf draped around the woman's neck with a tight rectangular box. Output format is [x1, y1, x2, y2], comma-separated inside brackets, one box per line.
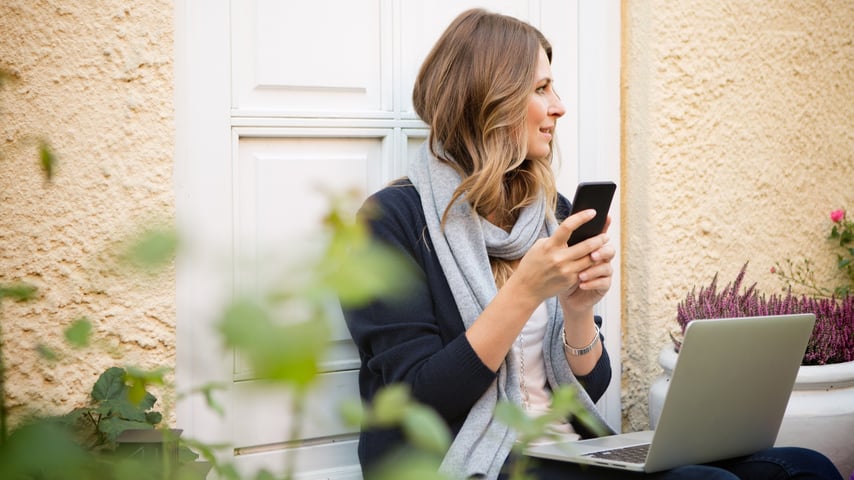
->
[409, 140, 606, 479]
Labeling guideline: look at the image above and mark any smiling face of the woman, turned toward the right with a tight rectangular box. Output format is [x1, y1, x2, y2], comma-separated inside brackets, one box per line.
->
[526, 48, 566, 159]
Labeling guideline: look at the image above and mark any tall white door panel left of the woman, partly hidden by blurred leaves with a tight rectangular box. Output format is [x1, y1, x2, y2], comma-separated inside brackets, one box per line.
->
[233, 135, 384, 398]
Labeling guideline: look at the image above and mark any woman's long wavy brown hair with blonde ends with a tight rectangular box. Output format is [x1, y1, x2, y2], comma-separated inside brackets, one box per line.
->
[412, 9, 557, 232]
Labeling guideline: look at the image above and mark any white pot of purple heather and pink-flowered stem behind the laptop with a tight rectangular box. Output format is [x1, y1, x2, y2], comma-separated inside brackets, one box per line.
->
[649, 210, 854, 473]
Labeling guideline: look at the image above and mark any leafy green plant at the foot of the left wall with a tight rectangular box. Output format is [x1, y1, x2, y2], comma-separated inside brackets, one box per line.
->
[0, 367, 211, 480]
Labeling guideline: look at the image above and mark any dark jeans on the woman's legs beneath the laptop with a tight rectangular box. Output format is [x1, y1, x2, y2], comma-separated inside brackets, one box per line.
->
[499, 447, 842, 480]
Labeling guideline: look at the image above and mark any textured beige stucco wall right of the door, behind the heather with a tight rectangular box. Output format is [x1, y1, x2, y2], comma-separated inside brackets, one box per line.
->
[622, 0, 854, 429]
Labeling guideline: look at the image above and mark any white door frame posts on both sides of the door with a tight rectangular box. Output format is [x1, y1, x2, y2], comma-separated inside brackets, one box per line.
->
[173, 0, 622, 458]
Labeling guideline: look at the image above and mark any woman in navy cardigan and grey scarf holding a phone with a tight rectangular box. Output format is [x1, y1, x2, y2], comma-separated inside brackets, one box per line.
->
[345, 9, 844, 479]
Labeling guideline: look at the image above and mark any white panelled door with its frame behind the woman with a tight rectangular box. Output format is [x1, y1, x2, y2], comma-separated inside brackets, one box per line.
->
[175, 0, 620, 478]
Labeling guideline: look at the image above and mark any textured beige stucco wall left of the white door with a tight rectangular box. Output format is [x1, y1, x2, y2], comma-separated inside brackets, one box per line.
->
[0, 0, 175, 424]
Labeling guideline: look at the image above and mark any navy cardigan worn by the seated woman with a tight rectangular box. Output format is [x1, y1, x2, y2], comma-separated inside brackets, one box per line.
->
[344, 179, 611, 469]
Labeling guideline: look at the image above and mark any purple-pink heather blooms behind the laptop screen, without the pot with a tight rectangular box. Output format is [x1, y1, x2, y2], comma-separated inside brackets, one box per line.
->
[673, 263, 854, 365]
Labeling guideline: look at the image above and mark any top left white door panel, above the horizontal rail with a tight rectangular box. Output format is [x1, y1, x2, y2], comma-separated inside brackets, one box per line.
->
[232, 0, 391, 114]
